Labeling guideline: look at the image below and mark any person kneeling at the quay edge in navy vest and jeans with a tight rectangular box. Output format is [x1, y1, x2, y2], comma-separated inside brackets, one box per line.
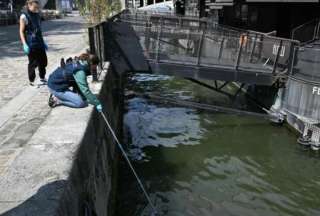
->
[48, 53, 102, 112]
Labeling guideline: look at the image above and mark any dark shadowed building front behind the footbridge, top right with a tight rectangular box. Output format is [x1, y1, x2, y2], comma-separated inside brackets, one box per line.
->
[174, 0, 320, 38]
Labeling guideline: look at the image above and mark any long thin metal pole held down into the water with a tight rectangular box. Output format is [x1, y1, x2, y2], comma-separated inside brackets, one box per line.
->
[101, 112, 159, 215]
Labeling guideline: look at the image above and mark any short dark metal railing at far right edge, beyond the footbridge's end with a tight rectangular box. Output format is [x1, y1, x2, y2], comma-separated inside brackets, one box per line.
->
[291, 18, 320, 44]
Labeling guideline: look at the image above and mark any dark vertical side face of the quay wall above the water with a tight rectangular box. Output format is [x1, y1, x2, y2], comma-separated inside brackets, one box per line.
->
[58, 66, 123, 216]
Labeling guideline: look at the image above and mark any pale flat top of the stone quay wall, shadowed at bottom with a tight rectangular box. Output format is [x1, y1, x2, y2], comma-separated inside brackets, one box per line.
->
[0, 96, 92, 215]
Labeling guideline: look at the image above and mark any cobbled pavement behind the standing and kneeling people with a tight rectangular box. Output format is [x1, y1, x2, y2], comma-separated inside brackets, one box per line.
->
[0, 12, 88, 108]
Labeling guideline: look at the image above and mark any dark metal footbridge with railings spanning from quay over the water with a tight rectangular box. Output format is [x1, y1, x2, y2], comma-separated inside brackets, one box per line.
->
[89, 10, 299, 85]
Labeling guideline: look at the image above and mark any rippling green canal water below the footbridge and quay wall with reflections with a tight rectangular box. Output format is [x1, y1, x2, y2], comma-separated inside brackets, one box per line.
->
[116, 74, 320, 216]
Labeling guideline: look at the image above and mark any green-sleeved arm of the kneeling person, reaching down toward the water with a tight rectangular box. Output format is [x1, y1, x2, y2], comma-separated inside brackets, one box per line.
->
[73, 70, 101, 106]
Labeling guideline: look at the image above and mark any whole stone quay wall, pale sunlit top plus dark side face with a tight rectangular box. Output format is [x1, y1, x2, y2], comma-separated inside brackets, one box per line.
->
[0, 65, 122, 216]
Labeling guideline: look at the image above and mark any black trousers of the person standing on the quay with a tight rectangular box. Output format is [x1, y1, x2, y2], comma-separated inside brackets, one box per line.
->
[28, 49, 48, 82]
